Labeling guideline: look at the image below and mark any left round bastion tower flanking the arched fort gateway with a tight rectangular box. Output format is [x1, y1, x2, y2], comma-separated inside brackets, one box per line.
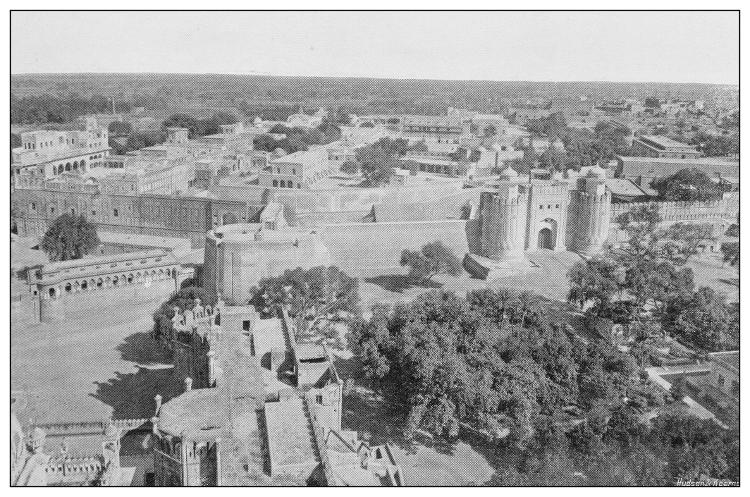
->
[479, 167, 529, 261]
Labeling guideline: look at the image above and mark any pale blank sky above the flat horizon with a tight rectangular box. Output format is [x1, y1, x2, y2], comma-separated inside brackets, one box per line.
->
[11, 12, 739, 84]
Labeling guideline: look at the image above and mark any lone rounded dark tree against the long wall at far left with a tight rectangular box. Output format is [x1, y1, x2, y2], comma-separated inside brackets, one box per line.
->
[39, 214, 100, 261]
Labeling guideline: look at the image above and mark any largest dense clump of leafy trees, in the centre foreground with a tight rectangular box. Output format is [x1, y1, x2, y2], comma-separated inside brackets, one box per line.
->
[349, 289, 661, 449]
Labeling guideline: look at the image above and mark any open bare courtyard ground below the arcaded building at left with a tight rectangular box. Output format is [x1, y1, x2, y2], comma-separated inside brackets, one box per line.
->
[11, 280, 179, 423]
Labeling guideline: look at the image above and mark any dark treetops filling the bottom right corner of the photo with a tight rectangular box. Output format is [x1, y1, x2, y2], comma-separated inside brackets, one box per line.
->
[488, 405, 739, 486]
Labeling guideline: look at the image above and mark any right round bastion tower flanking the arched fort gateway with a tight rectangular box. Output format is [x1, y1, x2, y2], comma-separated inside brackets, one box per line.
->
[574, 166, 612, 255]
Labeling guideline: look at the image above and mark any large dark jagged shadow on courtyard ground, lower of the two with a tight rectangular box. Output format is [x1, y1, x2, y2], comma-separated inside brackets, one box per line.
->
[90, 366, 180, 419]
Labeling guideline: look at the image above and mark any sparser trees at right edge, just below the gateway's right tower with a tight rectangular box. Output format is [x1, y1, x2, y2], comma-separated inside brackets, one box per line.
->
[568, 206, 739, 350]
